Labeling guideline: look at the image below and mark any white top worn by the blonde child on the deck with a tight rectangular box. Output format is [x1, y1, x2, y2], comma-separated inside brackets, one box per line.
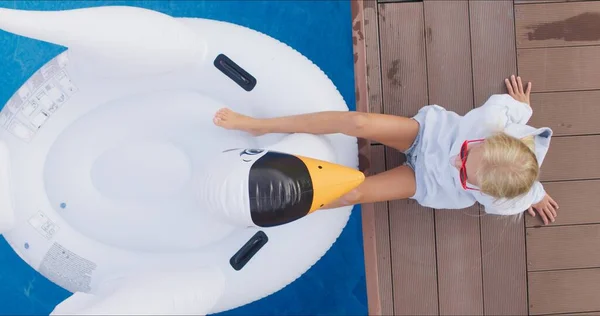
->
[414, 94, 552, 215]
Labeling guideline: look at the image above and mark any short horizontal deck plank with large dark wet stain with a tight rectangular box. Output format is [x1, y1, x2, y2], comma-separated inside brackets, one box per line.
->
[515, 2, 600, 48]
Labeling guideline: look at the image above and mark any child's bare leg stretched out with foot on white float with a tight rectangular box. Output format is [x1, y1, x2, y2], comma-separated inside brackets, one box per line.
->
[214, 109, 419, 151]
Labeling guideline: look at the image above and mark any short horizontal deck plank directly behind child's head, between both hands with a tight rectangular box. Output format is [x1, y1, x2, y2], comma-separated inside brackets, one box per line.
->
[540, 135, 600, 181]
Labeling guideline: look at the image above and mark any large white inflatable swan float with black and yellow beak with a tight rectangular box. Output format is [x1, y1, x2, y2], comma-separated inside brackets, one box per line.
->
[0, 7, 364, 315]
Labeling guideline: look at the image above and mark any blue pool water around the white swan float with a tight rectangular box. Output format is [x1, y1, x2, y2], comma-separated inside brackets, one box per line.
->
[0, 0, 367, 315]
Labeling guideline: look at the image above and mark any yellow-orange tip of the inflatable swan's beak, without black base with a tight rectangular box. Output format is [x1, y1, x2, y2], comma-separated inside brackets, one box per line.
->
[296, 156, 365, 214]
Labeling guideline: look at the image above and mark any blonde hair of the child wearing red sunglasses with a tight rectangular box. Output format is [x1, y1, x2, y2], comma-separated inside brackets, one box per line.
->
[477, 133, 539, 199]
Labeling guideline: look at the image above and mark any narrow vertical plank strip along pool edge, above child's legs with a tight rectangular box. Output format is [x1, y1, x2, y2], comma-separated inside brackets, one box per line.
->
[360, 0, 383, 113]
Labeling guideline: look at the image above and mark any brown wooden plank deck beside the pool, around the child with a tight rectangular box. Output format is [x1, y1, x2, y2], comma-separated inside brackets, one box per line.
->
[352, 0, 600, 315]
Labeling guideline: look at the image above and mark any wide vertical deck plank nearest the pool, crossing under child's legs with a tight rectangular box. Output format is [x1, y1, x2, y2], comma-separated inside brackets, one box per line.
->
[379, 3, 438, 315]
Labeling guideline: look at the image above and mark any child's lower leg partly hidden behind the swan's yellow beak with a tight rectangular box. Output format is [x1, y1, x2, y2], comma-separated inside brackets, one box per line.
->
[321, 166, 417, 209]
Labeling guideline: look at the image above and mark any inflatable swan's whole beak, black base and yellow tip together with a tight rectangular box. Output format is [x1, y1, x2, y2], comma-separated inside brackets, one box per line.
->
[248, 152, 365, 227]
